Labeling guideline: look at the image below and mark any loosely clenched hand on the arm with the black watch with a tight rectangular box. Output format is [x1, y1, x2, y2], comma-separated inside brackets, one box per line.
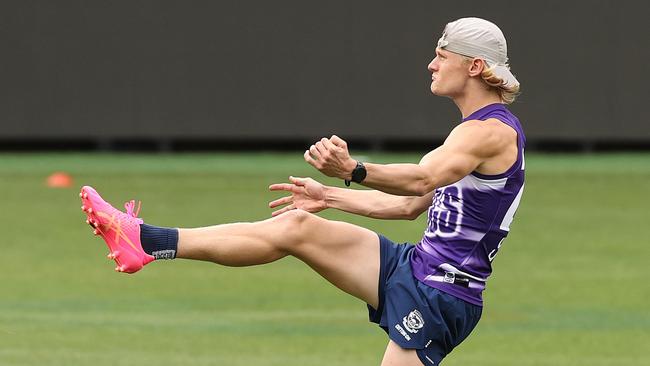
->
[304, 135, 357, 179]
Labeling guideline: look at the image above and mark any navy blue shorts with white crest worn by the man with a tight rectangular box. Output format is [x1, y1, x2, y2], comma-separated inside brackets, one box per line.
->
[368, 235, 483, 366]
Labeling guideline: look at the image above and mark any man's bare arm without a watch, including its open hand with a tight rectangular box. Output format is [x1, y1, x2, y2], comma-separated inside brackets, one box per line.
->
[269, 177, 433, 220]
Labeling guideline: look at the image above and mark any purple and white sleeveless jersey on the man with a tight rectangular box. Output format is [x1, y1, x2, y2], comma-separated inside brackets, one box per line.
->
[411, 104, 526, 306]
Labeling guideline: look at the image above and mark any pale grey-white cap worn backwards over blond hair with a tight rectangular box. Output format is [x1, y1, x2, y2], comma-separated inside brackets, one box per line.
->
[438, 18, 519, 87]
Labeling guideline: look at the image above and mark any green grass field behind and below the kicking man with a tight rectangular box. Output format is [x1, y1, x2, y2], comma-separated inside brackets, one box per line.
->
[0, 153, 650, 366]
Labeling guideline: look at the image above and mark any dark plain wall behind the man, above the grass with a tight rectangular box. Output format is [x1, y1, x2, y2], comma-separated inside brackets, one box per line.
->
[0, 0, 650, 151]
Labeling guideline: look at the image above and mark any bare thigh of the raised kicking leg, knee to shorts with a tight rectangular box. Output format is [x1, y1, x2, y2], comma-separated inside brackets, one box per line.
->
[287, 213, 380, 308]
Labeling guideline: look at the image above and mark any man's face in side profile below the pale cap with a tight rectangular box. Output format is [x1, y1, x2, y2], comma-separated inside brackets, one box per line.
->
[428, 48, 469, 98]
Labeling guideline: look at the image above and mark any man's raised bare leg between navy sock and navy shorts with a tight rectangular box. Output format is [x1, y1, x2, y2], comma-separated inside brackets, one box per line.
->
[177, 210, 379, 308]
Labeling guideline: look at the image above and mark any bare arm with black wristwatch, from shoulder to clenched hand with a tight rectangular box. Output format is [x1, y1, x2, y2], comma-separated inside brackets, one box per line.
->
[305, 120, 516, 196]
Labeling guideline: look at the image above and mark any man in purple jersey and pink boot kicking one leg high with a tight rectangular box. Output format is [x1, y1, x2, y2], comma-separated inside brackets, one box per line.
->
[80, 18, 525, 366]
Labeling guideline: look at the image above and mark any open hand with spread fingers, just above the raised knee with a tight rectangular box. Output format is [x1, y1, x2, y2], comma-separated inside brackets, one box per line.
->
[269, 177, 327, 216]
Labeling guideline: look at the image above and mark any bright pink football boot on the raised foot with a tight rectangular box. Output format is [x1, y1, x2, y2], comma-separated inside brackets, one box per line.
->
[79, 186, 154, 273]
